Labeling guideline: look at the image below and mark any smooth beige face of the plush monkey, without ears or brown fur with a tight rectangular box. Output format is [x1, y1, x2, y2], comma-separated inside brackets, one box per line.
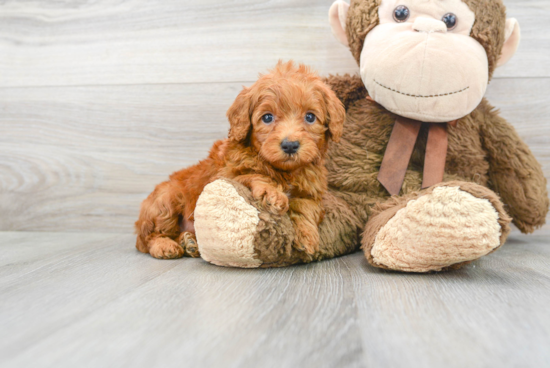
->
[360, 0, 489, 122]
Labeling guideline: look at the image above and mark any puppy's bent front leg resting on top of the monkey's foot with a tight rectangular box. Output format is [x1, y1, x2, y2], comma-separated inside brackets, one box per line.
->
[235, 174, 288, 215]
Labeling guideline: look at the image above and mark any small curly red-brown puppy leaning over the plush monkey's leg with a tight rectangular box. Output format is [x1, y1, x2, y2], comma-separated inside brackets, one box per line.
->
[135, 62, 345, 259]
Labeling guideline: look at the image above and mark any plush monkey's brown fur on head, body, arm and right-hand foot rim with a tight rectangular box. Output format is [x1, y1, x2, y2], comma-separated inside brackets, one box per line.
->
[326, 0, 549, 269]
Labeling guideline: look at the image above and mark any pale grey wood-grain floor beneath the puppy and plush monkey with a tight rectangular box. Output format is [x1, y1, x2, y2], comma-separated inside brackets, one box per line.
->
[0, 232, 550, 368]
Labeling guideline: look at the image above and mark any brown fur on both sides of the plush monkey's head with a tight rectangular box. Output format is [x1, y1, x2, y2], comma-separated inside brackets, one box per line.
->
[346, 0, 506, 79]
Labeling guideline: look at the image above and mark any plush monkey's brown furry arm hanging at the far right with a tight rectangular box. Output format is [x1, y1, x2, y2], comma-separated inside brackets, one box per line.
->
[476, 100, 548, 233]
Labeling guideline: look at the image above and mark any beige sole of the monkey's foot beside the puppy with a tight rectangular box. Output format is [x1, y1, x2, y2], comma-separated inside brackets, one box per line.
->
[195, 179, 262, 268]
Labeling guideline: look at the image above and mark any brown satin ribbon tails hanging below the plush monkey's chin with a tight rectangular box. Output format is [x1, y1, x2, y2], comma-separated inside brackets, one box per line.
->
[378, 116, 456, 195]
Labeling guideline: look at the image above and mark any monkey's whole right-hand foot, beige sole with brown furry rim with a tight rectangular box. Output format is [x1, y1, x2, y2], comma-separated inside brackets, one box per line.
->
[362, 181, 510, 272]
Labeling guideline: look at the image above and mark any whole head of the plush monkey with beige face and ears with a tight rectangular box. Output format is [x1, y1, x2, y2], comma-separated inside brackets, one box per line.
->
[329, 0, 520, 122]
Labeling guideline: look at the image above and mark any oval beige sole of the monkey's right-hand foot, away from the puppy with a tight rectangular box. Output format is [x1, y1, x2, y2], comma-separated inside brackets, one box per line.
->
[371, 186, 501, 272]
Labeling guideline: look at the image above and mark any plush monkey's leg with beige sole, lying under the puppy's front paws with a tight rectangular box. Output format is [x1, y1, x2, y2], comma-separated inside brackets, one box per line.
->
[195, 179, 358, 268]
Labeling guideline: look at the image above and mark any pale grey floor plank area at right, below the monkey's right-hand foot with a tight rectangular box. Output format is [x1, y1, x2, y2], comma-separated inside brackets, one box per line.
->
[348, 235, 550, 367]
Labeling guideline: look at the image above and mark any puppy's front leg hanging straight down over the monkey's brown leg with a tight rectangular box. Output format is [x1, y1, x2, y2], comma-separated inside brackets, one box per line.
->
[288, 198, 325, 254]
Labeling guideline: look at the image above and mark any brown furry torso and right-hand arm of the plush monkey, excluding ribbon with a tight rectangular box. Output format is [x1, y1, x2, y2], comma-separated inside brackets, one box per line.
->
[327, 75, 549, 233]
